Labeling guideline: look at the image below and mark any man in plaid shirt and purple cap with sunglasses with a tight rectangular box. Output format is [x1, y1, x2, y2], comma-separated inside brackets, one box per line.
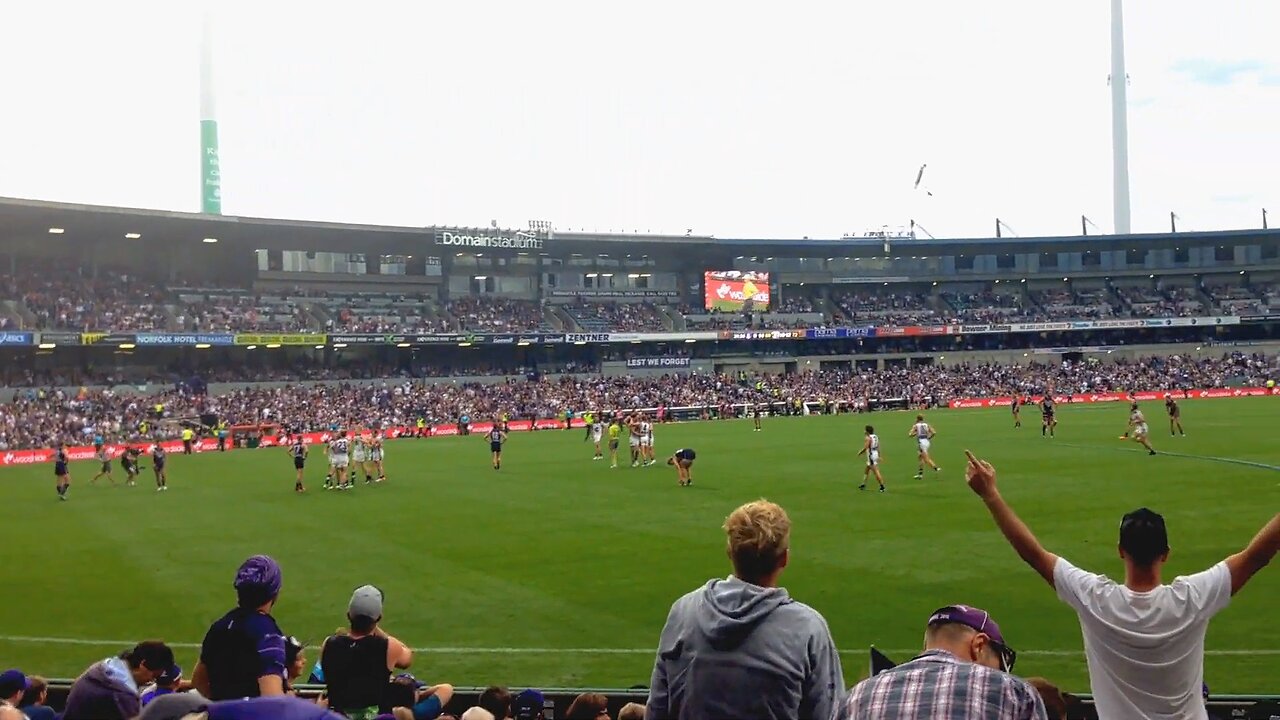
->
[836, 605, 1044, 720]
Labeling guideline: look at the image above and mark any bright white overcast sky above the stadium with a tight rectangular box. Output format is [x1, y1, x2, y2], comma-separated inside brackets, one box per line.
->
[0, 0, 1280, 237]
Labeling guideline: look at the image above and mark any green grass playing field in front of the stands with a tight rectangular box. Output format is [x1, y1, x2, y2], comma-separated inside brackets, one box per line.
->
[0, 398, 1280, 693]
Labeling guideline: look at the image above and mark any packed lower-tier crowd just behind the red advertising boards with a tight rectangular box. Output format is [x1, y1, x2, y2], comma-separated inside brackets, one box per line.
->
[0, 352, 1276, 450]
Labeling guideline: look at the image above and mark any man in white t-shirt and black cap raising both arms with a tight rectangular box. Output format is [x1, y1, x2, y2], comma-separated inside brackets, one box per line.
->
[965, 451, 1280, 720]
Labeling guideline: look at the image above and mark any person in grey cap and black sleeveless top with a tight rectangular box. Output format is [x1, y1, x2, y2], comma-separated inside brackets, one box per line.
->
[320, 585, 413, 720]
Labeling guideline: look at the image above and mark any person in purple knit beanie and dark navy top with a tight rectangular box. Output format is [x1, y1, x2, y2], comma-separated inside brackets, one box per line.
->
[191, 555, 285, 701]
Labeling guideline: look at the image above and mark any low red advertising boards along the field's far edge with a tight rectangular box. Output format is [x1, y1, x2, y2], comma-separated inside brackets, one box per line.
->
[0, 387, 1280, 468]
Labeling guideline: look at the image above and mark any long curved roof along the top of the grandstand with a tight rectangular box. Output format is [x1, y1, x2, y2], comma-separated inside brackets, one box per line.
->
[0, 197, 1280, 256]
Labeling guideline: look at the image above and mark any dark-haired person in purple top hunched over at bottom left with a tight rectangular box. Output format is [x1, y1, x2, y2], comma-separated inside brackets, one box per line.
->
[63, 641, 173, 720]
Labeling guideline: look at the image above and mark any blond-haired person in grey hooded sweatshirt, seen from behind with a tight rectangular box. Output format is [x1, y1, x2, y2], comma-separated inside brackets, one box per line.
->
[645, 500, 845, 720]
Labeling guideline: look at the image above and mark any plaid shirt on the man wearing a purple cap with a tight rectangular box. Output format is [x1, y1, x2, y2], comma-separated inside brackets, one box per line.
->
[836, 650, 1047, 720]
